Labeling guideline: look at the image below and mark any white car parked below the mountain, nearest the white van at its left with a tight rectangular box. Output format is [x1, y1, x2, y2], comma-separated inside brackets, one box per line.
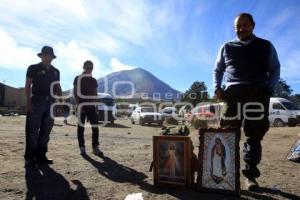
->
[130, 107, 164, 126]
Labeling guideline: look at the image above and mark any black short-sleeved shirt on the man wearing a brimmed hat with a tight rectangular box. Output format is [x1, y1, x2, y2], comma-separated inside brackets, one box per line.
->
[26, 63, 60, 96]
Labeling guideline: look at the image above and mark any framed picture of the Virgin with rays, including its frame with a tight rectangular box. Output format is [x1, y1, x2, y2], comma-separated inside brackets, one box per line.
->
[197, 129, 240, 195]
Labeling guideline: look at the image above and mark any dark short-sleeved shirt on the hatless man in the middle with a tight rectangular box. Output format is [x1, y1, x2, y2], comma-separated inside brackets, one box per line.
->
[73, 75, 98, 102]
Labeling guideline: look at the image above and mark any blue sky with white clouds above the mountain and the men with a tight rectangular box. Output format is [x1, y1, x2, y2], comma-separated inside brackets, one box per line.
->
[0, 0, 300, 93]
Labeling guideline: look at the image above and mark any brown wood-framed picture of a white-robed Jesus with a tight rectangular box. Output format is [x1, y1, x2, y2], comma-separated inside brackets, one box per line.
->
[153, 136, 191, 187]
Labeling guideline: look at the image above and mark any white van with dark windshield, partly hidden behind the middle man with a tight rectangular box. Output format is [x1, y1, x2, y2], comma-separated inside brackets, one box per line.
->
[97, 93, 117, 124]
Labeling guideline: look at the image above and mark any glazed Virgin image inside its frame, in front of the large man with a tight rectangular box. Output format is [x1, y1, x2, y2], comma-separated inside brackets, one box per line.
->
[202, 132, 237, 191]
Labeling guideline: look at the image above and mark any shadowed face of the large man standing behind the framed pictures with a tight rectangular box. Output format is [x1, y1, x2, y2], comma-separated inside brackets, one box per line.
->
[234, 17, 254, 41]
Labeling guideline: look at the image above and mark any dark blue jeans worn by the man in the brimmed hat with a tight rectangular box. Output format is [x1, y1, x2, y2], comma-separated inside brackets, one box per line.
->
[24, 98, 54, 159]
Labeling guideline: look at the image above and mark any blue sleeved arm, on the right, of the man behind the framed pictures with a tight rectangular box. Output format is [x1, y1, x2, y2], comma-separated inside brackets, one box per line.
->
[268, 43, 280, 94]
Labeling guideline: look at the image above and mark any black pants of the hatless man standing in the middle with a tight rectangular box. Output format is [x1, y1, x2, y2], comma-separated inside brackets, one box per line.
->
[77, 106, 99, 148]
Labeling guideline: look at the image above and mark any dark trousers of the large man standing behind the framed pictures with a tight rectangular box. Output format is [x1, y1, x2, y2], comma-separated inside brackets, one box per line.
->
[221, 84, 270, 178]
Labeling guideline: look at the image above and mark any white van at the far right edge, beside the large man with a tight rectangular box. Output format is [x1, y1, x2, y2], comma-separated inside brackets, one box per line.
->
[269, 97, 300, 127]
